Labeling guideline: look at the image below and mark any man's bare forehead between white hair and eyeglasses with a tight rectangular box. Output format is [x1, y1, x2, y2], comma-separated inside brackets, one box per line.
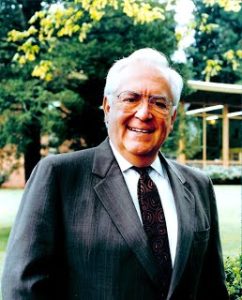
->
[117, 63, 171, 97]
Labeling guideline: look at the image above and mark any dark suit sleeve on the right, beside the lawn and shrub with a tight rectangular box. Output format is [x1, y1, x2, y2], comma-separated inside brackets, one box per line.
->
[197, 180, 229, 300]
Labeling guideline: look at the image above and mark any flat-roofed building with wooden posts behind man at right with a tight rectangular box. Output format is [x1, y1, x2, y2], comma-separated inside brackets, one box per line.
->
[178, 80, 242, 167]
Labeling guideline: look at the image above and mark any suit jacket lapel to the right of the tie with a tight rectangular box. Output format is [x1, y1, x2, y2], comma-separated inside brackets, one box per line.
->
[162, 157, 195, 299]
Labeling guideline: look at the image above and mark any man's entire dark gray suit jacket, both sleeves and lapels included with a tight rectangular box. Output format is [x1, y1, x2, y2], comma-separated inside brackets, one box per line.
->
[2, 140, 228, 300]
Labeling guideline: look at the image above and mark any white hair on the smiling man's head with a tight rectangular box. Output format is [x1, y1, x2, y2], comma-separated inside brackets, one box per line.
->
[104, 48, 183, 106]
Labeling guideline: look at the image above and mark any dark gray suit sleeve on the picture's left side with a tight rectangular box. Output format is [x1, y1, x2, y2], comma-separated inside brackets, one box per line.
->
[2, 158, 65, 300]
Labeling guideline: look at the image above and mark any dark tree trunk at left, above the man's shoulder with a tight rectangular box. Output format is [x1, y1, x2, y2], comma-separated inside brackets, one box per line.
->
[24, 123, 41, 181]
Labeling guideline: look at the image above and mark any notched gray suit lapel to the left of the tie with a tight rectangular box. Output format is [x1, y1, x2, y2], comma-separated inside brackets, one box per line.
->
[93, 140, 163, 286]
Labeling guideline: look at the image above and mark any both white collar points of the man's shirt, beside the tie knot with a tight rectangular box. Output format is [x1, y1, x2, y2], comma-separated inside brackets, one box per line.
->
[109, 139, 164, 177]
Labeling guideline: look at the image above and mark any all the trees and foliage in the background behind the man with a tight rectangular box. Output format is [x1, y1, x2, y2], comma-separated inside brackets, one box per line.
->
[0, 0, 242, 183]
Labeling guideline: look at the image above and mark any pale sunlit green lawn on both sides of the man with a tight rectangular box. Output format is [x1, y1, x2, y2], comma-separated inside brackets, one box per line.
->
[0, 185, 241, 300]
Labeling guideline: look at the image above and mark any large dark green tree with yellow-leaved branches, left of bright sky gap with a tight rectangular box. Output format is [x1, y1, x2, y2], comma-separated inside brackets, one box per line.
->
[0, 0, 191, 178]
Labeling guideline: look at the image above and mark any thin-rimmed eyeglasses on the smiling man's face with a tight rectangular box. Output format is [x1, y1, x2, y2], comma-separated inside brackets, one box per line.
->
[117, 91, 175, 116]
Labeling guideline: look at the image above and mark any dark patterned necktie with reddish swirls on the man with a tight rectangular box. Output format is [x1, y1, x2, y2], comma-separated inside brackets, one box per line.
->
[134, 167, 172, 300]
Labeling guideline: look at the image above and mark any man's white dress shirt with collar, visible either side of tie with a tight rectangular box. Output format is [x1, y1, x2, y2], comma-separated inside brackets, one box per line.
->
[110, 141, 178, 265]
